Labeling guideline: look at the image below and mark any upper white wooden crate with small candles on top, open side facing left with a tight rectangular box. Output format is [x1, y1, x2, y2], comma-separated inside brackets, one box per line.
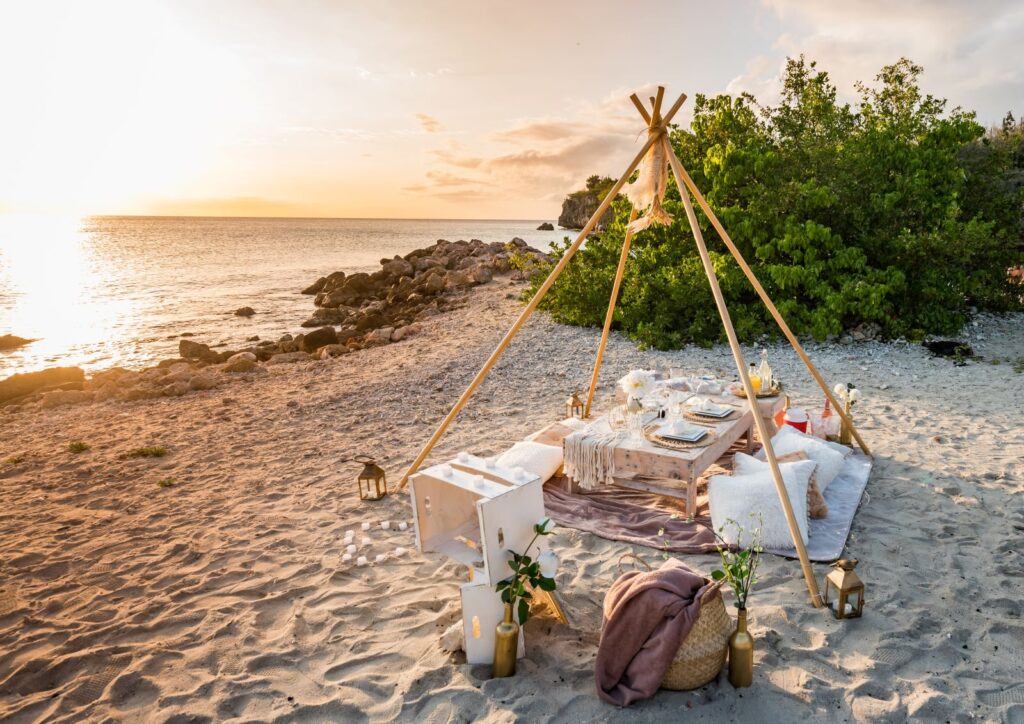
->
[409, 456, 548, 586]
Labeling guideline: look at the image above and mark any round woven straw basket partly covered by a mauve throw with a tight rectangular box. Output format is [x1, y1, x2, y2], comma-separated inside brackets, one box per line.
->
[662, 583, 735, 691]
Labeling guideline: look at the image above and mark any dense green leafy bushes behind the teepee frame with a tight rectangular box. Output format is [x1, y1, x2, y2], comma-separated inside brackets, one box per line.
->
[535, 56, 1024, 348]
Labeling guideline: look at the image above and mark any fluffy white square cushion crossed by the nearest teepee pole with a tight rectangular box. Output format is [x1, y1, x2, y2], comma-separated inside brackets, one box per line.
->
[708, 460, 815, 548]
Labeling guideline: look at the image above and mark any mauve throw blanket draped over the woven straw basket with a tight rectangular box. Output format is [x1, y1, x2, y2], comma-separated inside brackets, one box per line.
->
[594, 558, 710, 707]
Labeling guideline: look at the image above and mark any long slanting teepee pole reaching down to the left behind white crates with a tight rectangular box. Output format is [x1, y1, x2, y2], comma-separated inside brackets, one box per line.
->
[398, 128, 665, 491]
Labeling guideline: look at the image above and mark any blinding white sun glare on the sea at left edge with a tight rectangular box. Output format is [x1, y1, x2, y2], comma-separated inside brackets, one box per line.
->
[0, 215, 135, 377]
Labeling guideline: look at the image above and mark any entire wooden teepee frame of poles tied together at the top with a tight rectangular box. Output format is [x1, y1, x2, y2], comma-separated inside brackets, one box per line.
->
[399, 86, 870, 607]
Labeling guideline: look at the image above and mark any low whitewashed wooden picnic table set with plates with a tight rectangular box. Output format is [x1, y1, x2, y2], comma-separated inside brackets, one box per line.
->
[569, 397, 782, 518]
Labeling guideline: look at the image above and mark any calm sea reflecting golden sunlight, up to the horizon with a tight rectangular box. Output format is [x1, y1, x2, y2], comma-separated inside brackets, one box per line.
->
[0, 216, 565, 379]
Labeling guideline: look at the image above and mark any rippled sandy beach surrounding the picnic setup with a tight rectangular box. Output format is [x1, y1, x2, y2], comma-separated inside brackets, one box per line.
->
[0, 282, 1024, 721]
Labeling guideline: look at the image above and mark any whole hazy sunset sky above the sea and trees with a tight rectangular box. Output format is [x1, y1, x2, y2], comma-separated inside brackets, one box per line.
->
[0, 0, 1024, 219]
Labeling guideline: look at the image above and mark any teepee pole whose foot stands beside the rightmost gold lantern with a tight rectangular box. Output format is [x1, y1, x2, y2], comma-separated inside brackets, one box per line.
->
[662, 136, 821, 608]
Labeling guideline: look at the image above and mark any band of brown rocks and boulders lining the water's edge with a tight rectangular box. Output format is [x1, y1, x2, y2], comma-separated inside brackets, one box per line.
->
[0, 238, 549, 409]
